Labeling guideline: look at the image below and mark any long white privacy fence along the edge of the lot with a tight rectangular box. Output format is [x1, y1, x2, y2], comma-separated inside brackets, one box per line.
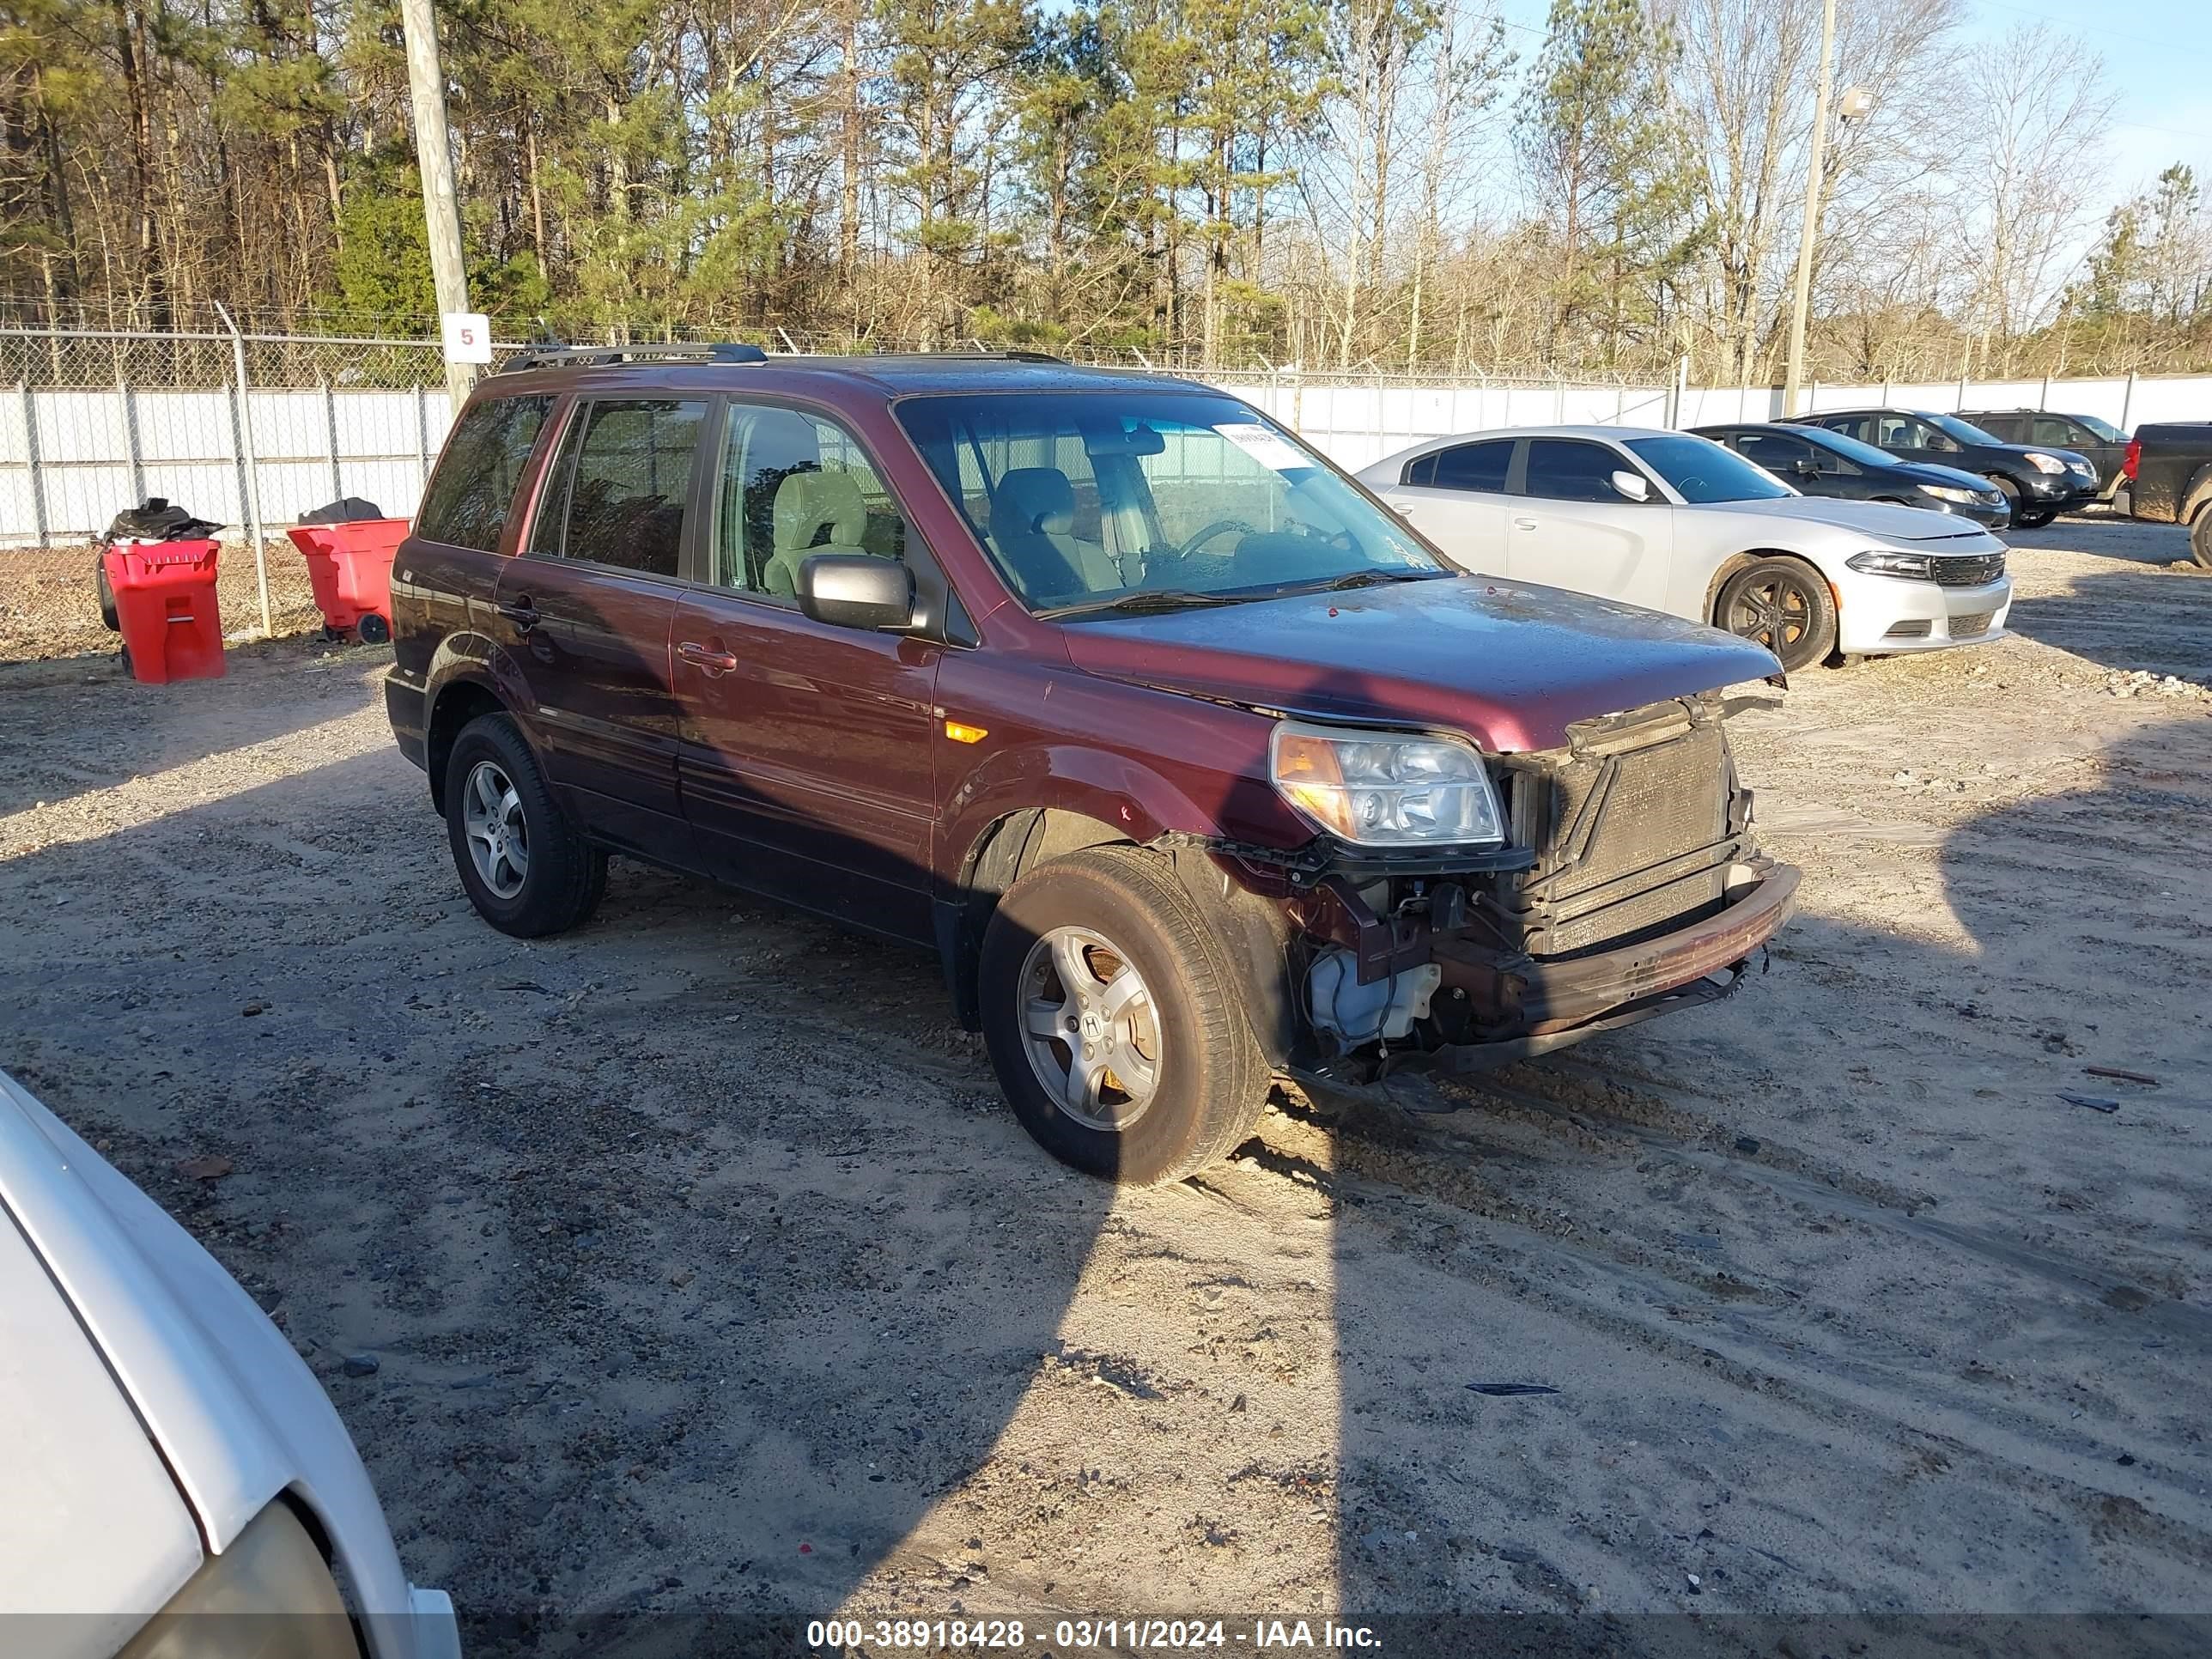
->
[0, 330, 2212, 546]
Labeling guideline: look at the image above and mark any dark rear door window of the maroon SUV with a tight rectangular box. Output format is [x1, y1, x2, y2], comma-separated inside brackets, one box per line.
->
[531, 398, 706, 575]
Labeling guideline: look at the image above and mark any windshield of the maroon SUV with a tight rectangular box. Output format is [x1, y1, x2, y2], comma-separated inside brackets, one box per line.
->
[894, 387, 1451, 615]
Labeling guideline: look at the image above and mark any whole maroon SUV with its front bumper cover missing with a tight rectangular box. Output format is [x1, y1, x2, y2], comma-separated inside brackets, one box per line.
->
[387, 345, 1796, 1183]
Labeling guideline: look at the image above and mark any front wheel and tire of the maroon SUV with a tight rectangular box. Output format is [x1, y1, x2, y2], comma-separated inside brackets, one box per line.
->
[978, 848, 1267, 1186]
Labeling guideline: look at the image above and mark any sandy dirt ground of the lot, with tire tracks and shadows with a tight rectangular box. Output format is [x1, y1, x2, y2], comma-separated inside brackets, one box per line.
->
[0, 520, 2212, 1659]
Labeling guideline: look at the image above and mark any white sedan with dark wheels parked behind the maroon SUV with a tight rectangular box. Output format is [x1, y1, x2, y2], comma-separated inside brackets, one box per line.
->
[1360, 427, 2013, 671]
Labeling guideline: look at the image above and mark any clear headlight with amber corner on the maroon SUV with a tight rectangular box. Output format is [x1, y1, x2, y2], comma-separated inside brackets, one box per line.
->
[1267, 721, 1506, 848]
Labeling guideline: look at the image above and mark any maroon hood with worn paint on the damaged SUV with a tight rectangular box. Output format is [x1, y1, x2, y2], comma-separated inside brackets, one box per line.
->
[1064, 575, 1778, 752]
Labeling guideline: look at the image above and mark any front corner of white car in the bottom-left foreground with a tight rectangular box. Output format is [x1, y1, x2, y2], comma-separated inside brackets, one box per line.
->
[0, 1073, 460, 1659]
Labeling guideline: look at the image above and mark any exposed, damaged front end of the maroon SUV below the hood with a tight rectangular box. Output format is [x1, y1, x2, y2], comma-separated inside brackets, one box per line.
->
[1214, 696, 1798, 1086]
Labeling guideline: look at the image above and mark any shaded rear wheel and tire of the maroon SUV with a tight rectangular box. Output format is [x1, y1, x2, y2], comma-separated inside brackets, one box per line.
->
[445, 714, 606, 938]
